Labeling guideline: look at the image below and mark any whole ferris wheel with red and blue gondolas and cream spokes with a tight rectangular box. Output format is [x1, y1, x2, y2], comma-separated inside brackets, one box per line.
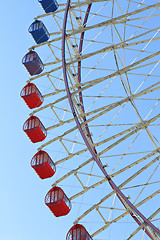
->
[21, 0, 160, 240]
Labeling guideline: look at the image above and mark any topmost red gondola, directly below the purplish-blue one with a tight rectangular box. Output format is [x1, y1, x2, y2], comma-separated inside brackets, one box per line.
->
[20, 83, 44, 109]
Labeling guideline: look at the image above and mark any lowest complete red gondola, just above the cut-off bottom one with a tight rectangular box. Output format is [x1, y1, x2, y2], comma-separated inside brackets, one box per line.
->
[45, 187, 71, 217]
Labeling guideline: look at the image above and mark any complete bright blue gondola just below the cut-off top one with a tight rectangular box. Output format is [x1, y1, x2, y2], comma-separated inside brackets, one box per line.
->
[28, 20, 50, 44]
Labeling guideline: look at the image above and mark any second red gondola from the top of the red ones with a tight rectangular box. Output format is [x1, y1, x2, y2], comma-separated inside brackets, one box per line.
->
[23, 116, 47, 143]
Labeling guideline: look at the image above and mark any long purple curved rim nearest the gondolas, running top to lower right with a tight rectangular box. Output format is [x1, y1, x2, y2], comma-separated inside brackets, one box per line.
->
[62, 0, 160, 237]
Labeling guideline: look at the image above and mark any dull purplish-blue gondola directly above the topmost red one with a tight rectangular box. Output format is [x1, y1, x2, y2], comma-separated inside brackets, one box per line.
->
[22, 51, 44, 76]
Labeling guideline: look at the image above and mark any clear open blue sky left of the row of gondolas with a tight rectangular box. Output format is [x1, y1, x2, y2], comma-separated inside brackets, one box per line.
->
[0, 0, 73, 240]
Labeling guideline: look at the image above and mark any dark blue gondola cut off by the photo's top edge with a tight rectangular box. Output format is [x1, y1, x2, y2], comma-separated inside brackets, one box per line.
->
[38, 0, 58, 13]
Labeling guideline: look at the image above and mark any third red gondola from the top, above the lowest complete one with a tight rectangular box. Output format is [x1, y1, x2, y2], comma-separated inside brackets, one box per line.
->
[31, 151, 56, 179]
